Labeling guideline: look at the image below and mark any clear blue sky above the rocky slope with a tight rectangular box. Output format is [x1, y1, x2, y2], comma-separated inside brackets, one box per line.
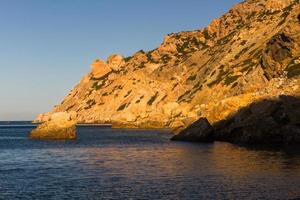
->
[0, 0, 240, 120]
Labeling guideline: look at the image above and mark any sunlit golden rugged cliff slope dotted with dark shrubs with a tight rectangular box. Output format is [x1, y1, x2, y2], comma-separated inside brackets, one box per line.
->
[37, 0, 300, 129]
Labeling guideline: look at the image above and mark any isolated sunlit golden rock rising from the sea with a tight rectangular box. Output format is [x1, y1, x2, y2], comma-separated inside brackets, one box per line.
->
[29, 112, 77, 140]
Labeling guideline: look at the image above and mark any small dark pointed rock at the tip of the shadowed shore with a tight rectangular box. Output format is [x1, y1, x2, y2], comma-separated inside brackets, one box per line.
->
[171, 118, 214, 142]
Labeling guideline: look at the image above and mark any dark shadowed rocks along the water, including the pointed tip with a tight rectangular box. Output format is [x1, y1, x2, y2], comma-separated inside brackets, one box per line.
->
[172, 96, 300, 145]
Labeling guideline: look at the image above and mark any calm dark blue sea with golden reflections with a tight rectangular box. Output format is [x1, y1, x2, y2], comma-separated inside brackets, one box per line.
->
[0, 122, 300, 200]
